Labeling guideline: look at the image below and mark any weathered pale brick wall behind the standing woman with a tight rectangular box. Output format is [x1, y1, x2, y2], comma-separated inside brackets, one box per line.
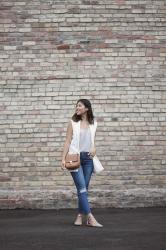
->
[0, 0, 166, 209]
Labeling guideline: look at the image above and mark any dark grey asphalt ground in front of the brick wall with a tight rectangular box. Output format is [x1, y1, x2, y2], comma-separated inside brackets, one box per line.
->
[0, 207, 166, 250]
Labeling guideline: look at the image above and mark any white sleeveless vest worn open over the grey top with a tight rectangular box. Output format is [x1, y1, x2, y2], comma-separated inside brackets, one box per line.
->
[69, 120, 97, 154]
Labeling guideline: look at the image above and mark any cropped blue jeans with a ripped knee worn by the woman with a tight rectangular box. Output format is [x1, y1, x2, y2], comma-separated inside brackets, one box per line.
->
[70, 152, 94, 214]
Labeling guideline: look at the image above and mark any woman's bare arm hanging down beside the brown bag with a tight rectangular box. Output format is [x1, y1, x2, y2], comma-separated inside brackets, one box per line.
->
[61, 121, 73, 169]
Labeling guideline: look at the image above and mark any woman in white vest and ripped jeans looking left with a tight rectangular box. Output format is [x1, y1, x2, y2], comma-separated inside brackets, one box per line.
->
[61, 99, 103, 227]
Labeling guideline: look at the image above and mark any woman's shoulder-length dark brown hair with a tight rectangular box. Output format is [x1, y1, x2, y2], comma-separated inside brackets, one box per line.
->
[72, 99, 94, 124]
